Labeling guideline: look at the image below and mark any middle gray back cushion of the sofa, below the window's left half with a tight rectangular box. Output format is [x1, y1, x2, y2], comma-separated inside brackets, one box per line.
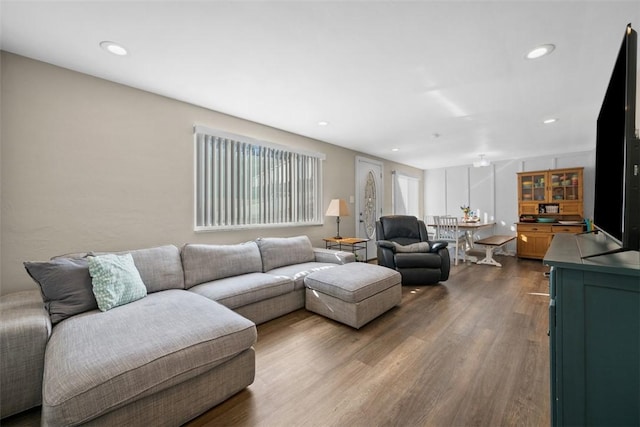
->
[182, 242, 262, 289]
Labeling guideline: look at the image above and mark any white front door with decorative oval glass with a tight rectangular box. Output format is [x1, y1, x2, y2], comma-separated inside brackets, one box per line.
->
[356, 157, 382, 261]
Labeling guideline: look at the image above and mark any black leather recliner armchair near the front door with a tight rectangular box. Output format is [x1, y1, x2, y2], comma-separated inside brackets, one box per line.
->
[376, 215, 451, 285]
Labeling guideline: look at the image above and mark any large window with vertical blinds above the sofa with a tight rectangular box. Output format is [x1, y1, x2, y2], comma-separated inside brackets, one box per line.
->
[194, 126, 324, 231]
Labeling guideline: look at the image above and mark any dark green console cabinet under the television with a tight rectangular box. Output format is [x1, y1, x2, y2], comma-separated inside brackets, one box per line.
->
[544, 234, 640, 426]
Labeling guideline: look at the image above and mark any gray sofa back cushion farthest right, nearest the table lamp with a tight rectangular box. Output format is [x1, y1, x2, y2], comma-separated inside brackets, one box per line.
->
[256, 236, 315, 272]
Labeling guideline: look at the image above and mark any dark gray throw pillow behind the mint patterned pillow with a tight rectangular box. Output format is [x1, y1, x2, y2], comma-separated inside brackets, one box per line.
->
[24, 258, 98, 324]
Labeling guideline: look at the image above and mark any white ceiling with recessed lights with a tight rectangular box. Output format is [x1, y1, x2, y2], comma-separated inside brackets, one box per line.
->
[0, 0, 640, 169]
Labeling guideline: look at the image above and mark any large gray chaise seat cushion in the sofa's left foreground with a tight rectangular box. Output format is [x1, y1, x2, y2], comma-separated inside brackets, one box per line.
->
[42, 290, 256, 425]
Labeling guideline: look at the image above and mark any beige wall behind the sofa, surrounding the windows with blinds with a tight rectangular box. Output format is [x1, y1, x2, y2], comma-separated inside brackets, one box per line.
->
[0, 52, 424, 294]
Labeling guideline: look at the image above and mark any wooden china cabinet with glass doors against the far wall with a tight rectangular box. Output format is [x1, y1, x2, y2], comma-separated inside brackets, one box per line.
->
[517, 168, 584, 259]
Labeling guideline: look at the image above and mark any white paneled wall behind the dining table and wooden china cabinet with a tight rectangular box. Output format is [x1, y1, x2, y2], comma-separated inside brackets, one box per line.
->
[424, 149, 595, 254]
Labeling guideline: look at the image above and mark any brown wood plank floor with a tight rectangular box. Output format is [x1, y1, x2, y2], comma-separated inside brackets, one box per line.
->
[188, 257, 550, 427]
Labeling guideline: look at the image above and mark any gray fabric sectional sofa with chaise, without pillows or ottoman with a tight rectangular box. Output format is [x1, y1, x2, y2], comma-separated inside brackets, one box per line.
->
[0, 236, 355, 426]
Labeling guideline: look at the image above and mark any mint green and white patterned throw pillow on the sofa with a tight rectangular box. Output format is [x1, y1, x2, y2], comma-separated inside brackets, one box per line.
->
[88, 254, 147, 311]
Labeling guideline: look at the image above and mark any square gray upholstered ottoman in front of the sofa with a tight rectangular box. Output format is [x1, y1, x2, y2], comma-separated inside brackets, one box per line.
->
[304, 262, 402, 329]
